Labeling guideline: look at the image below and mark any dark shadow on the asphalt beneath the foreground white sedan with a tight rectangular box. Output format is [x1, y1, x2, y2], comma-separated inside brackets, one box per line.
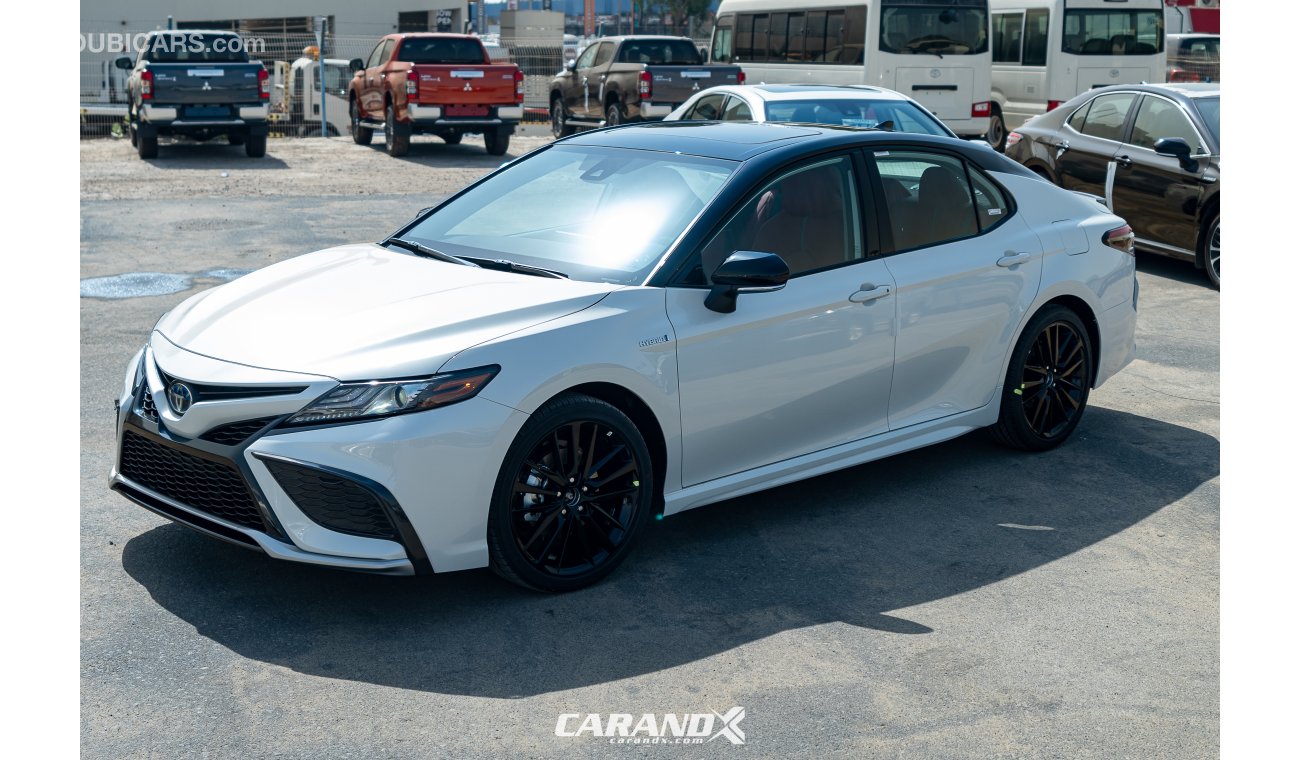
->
[122, 408, 1218, 698]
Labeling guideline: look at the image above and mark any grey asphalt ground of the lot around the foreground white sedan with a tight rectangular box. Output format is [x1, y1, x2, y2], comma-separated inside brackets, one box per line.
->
[81, 138, 1219, 760]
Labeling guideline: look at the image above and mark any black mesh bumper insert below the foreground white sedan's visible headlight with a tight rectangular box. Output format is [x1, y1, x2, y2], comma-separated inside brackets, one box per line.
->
[263, 457, 398, 539]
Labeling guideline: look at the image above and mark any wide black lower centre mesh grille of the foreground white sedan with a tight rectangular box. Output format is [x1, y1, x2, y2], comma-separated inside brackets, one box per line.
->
[118, 430, 267, 530]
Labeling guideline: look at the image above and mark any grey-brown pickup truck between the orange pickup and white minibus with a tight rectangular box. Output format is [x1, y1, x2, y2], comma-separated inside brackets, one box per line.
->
[550, 35, 745, 138]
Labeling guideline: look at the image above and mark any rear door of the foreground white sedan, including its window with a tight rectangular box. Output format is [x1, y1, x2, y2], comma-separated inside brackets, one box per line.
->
[871, 148, 1043, 430]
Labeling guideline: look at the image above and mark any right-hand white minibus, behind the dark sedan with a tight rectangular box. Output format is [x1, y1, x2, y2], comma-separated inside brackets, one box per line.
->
[988, 0, 1165, 151]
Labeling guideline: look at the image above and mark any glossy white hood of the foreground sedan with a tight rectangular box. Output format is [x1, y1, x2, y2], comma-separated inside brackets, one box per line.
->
[156, 244, 621, 381]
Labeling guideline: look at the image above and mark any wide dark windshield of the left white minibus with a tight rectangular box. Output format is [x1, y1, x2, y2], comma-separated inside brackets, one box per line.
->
[880, 0, 988, 56]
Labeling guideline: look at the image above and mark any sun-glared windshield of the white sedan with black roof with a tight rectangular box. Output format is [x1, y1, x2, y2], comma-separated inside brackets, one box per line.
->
[402, 146, 737, 285]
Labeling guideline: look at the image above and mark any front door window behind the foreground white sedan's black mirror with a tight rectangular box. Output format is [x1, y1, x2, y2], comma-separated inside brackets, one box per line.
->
[701, 157, 862, 281]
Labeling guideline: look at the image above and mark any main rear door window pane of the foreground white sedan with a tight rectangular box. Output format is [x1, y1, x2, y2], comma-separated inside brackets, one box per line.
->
[875, 151, 977, 251]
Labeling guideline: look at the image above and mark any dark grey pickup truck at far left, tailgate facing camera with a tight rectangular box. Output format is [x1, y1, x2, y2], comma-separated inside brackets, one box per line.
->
[116, 30, 270, 158]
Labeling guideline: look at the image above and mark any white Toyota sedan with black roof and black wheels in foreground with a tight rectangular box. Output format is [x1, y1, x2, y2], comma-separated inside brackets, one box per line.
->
[111, 122, 1138, 591]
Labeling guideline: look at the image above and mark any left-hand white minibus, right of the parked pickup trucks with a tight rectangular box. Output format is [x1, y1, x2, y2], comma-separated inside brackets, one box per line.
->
[709, 0, 992, 138]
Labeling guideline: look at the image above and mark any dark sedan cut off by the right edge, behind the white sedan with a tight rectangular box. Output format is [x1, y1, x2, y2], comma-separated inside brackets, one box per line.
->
[1006, 83, 1222, 287]
